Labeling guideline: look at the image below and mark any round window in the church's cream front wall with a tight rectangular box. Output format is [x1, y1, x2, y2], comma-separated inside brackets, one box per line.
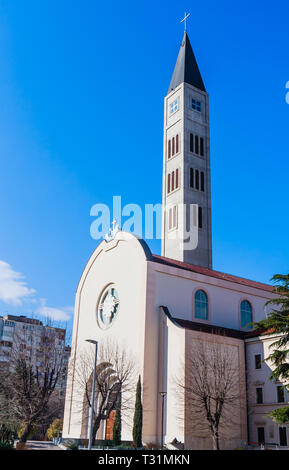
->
[97, 285, 119, 329]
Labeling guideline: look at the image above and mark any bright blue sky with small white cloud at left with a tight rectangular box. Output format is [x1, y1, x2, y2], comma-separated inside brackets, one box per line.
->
[0, 0, 289, 332]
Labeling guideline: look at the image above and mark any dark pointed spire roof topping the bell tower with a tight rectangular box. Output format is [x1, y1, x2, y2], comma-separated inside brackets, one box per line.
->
[168, 31, 206, 92]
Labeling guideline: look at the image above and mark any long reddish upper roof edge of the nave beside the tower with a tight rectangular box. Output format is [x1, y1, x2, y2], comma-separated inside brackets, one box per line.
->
[152, 255, 274, 292]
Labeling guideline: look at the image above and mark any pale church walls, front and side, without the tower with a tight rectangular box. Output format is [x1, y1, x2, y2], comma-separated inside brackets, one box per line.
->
[63, 231, 280, 448]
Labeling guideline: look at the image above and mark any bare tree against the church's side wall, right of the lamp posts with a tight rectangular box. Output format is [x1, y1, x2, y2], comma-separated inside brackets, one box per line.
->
[177, 340, 242, 450]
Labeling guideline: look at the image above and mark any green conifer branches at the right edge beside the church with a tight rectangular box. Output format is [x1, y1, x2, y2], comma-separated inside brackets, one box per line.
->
[254, 274, 289, 386]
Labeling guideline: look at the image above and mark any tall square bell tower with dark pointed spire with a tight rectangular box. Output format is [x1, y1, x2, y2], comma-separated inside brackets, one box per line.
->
[162, 28, 212, 269]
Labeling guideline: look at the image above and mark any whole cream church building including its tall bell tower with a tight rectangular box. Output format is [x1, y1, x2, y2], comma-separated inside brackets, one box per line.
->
[63, 27, 288, 449]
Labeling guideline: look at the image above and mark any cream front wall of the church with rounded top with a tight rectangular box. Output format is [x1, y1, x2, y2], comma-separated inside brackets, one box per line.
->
[63, 232, 146, 440]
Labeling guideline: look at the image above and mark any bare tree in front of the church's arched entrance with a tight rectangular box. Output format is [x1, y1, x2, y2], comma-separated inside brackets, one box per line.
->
[74, 341, 136, 443]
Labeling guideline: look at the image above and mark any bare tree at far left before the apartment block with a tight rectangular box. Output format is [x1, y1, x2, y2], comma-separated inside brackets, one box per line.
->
[1, 322, 65, 442]
